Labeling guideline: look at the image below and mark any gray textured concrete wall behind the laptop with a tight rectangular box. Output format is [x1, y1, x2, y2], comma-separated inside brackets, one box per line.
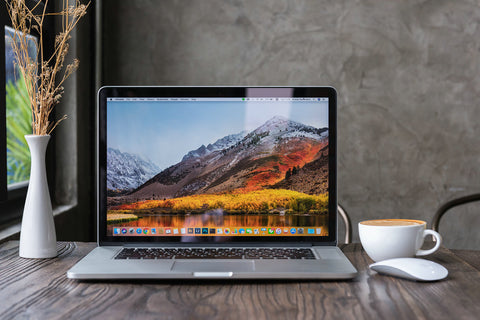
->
[102, 0, 480, 248]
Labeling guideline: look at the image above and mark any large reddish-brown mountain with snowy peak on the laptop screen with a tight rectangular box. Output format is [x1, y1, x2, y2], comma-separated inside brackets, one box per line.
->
[125, 116, 328, 200]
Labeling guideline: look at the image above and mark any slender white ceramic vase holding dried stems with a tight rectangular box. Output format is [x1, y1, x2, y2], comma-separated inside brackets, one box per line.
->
[19, 135, 57, 258]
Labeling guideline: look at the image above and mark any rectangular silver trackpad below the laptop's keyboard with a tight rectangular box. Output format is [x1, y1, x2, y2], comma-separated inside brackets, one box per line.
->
[172, 260, 255, 272]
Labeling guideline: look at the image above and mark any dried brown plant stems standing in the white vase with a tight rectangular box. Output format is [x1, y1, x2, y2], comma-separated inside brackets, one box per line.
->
[5, 0, 90, 135]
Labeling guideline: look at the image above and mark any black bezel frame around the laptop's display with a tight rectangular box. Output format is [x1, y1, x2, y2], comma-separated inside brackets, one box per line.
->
[97, 86, 337, 246]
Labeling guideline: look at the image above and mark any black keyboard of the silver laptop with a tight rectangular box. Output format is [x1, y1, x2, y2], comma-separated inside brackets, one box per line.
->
[115, 248, 315, 260]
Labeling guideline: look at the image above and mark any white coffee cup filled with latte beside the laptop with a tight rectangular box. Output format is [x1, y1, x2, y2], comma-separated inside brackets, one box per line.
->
[358, 219, 442, 262]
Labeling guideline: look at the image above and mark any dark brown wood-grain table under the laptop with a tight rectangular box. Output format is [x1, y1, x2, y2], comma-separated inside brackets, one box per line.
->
[0, 241, 480, 320]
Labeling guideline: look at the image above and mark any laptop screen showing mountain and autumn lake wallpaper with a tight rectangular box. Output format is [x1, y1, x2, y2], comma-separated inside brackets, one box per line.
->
[99, 88, 336, 242]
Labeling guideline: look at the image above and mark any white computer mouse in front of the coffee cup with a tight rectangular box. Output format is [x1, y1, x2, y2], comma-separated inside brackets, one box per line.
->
[370, 258, 448, 281]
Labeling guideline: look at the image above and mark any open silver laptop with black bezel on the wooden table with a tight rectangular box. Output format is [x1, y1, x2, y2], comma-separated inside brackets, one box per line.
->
[67, 87, 357, 279]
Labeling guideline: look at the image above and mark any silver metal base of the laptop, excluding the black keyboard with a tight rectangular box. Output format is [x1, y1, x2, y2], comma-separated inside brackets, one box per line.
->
[67, 246, 357, 279]
